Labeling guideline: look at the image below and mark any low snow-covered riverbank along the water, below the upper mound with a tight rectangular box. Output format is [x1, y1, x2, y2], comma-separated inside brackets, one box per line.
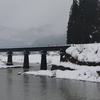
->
[23, 62, 100, 82]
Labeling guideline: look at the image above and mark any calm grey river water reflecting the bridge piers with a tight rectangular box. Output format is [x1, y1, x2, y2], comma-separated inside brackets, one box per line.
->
[0, 65, 100, 100]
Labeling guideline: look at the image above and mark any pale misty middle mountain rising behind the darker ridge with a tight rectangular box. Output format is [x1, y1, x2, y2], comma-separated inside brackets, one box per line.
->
[16, 27, 51, 44]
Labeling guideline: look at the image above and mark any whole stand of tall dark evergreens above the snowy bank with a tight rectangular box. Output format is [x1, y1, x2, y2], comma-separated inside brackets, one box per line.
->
[67, 0, 100, 44]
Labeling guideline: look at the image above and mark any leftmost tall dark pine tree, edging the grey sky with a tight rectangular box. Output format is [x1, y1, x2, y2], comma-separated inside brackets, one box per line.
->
[67, 0, 78, 44]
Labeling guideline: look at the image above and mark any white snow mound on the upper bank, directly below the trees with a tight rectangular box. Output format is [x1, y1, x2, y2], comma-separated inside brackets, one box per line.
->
[66, 44, 100, 63]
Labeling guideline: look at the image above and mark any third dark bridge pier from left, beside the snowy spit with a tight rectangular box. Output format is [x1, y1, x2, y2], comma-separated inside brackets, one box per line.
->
[40, 51, 47, 70]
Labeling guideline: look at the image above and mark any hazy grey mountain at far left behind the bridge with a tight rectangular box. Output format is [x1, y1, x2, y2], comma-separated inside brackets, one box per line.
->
[0, 26, 25, 47]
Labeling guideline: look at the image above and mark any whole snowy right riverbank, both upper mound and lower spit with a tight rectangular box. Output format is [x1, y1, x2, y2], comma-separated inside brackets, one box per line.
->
[24, 44, 100, 82]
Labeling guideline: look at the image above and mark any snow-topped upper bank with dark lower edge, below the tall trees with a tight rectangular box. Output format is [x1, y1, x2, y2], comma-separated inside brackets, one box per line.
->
[66, 43, 100, 66]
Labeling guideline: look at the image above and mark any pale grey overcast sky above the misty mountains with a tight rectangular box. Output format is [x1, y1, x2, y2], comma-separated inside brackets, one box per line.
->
[0, 0, 72, 29]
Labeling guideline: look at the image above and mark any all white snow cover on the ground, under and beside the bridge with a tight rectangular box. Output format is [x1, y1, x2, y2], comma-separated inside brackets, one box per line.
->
[0, 44, 100, 82]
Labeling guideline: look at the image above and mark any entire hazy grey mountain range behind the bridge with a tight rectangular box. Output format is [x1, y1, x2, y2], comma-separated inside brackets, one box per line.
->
[0, 25, 66, 47]
